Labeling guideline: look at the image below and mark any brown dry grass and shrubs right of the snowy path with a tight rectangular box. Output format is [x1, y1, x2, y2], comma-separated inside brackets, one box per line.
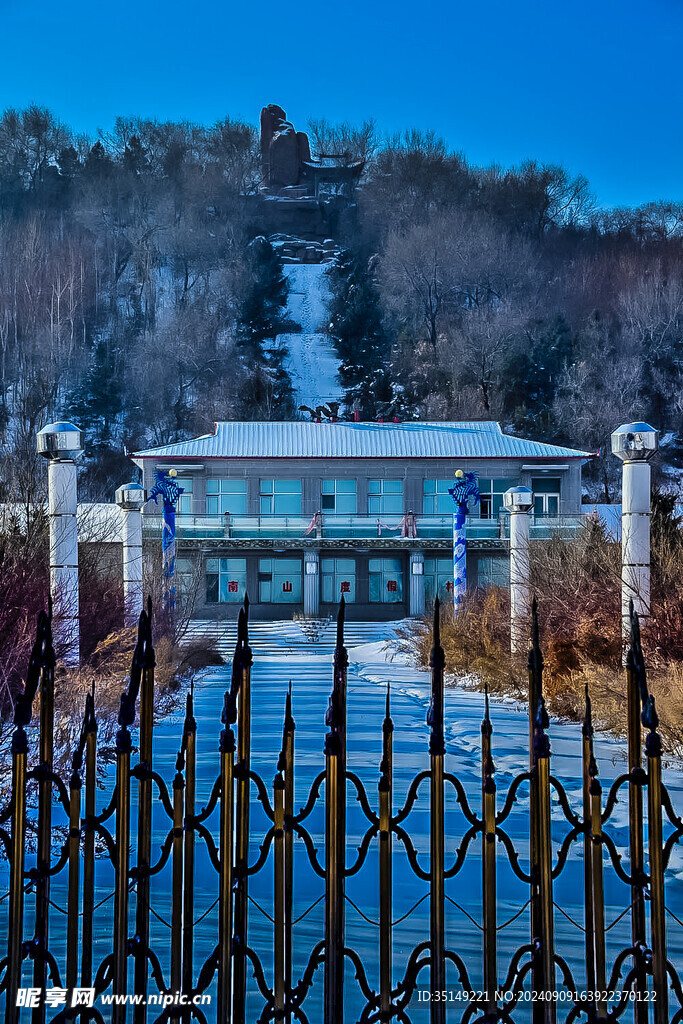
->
[405, 496, 683, 755]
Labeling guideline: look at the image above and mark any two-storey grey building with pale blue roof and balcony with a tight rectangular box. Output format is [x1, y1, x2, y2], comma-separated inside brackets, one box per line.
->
[132, 422, 589, 620]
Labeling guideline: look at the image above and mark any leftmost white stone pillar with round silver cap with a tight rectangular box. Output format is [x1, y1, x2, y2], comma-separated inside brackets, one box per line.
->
[37, 422, 83, 665]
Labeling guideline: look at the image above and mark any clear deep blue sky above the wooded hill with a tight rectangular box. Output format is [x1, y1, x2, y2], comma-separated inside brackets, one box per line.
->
[0, 0, 683, 206]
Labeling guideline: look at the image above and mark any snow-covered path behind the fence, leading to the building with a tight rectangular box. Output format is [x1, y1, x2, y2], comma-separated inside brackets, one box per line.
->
[1, 623, 683, 1024]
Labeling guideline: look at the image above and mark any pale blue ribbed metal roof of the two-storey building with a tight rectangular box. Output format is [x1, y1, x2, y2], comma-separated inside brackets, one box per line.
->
[132, 421, 589, 461]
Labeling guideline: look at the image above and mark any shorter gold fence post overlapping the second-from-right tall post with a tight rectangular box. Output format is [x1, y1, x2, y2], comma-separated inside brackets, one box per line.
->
[531, 697, 556, 1024]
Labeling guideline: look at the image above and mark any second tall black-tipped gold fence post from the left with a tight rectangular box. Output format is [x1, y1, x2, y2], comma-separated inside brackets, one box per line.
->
[132, 601, 155, 1024]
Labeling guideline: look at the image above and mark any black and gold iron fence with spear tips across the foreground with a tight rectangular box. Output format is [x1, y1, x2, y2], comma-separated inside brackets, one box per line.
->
[0, 602, 683, 1024]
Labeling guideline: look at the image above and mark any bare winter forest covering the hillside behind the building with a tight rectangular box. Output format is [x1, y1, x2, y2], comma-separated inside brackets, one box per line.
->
[0, 106, 683, 500]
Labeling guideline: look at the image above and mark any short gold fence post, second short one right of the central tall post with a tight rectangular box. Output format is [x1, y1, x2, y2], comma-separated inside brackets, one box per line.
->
[481, 692, 498, 1019]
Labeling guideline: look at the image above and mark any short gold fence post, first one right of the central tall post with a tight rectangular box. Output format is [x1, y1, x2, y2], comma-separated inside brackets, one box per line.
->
[379, 683, 393, 1020]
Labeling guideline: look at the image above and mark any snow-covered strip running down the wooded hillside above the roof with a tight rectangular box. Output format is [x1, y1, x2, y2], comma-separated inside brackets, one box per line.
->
[278, 263, 343, 408]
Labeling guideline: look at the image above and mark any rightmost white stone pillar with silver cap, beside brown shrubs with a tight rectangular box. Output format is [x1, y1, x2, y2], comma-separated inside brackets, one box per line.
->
[611, 423, 659, 638]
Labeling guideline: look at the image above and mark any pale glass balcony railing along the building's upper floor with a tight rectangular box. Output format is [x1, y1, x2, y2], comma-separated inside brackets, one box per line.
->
[143, 513, 586, 541]
